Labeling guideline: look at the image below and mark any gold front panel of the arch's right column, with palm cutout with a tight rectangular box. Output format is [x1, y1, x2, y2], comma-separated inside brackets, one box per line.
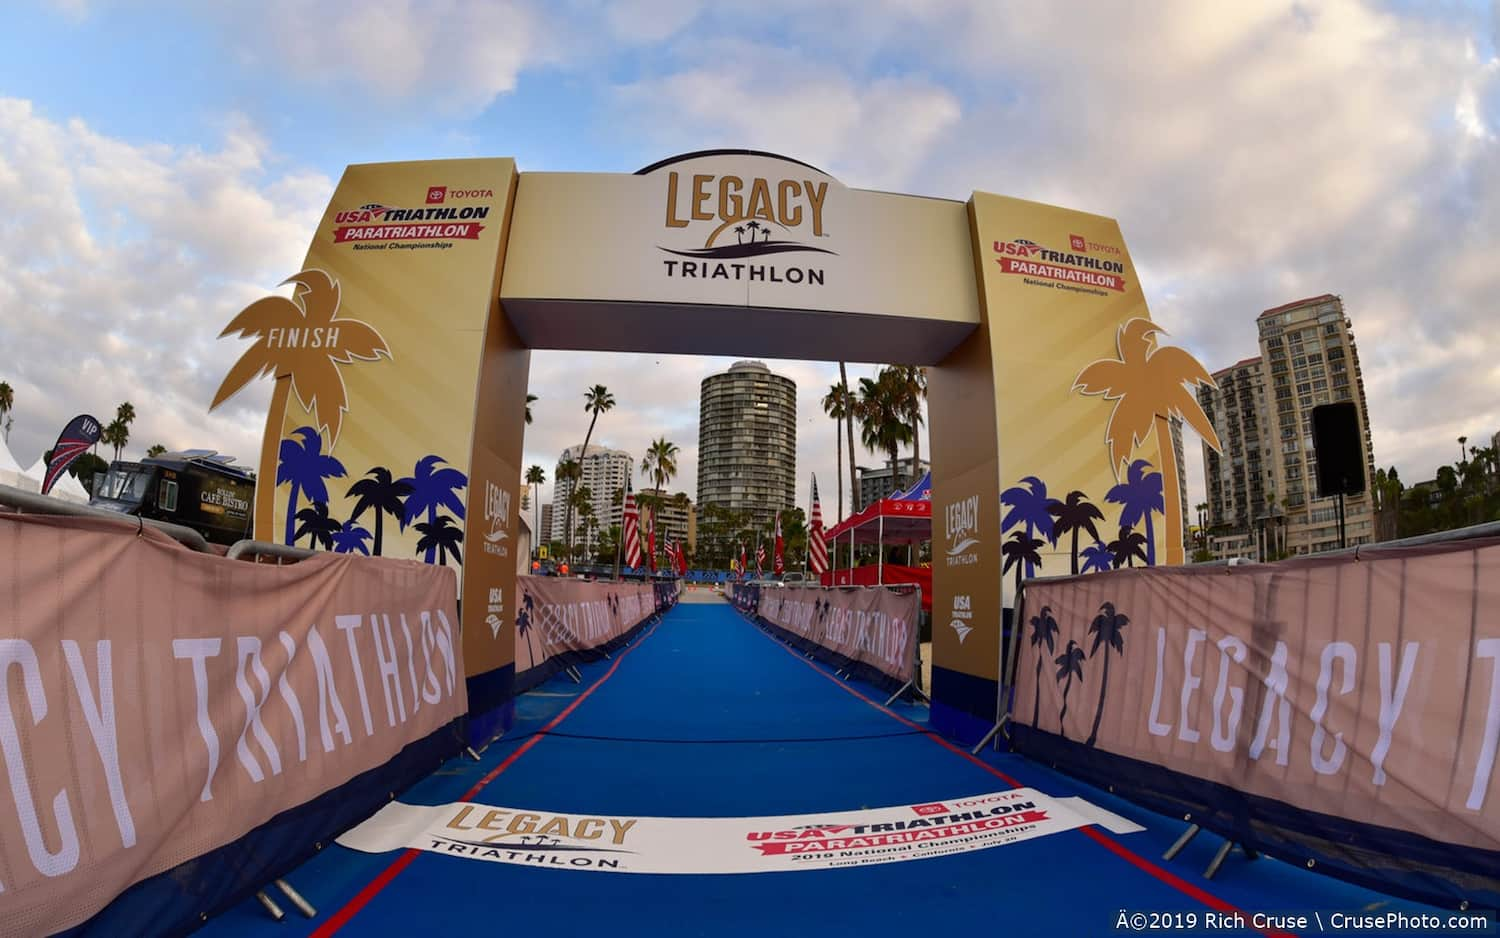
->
[972, 192, 1218, 591]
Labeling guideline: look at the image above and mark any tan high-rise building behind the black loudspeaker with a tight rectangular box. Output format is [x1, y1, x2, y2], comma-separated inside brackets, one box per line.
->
[1199, 294, 1376, 558]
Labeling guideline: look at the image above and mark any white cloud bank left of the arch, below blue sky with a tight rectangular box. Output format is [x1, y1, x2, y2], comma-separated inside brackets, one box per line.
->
[0, 99, 333, 464]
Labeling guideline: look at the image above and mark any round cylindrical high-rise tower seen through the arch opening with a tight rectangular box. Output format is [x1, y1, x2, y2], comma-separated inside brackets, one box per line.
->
[698, 362, 797, 525]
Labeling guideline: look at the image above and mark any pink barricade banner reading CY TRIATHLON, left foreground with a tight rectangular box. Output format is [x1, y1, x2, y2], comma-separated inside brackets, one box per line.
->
[0, 515, 467, 935]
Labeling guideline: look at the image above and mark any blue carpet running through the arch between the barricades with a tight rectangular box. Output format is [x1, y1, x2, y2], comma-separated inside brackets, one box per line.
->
[204, 605, 1452, 938]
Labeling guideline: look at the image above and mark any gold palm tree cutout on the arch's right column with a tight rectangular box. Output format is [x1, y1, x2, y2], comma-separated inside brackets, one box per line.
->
[1073, 318, 1220, 563]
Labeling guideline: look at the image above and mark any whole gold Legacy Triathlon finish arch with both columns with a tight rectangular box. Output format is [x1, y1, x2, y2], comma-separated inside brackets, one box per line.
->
[216, 150, 1208, 740]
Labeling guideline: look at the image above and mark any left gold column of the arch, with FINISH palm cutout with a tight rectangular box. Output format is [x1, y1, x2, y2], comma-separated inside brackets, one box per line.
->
[215, 159, 527, 732]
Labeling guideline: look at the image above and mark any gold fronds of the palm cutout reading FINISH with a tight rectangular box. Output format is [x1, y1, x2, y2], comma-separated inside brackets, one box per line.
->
[217, 269, 392, 450]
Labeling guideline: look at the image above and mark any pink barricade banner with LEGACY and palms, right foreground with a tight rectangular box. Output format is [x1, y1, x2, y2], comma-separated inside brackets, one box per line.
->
[1013, 540, 1500, 908]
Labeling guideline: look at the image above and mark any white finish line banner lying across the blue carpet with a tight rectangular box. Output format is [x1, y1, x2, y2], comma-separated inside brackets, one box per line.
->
[338, 788, 1097, 873]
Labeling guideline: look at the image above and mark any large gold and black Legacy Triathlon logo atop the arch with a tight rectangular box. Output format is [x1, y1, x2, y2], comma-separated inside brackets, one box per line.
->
[657, 171, 836, 285]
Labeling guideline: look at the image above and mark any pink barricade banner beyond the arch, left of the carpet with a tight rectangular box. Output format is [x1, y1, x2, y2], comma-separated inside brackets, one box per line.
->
[516, 576, 657, 693]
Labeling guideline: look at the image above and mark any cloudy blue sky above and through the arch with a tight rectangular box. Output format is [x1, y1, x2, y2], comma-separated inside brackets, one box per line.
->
[0, 0, 1500, 513]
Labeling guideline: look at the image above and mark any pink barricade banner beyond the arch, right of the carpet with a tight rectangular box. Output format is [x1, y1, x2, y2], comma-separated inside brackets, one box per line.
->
[735, 587, 921, 686]
